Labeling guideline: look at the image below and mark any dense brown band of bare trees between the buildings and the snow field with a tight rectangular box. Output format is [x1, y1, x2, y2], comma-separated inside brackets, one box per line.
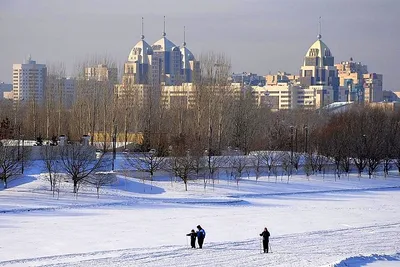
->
[0, 53, 400, 193]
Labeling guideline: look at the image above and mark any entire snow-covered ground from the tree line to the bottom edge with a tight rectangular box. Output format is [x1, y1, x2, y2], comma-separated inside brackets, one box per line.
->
[0, 158, 400, 267]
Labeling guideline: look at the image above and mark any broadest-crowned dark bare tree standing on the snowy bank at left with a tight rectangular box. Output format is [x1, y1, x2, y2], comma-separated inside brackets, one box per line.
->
[60, 143, 104, 194]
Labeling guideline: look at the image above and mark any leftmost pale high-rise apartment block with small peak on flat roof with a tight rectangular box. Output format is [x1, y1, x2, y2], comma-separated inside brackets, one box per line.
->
[13, 57, 47, 102]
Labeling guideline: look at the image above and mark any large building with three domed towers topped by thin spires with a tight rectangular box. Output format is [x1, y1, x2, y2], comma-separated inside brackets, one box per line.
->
[115, 22, 200, 106]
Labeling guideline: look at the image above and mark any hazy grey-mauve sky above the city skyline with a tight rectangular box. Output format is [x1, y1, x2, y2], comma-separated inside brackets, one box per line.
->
[0, 0, 400, 91]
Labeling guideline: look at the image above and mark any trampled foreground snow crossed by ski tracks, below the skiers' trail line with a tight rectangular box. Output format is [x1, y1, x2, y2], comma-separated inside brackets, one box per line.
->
[0, 222, 400, 267]
